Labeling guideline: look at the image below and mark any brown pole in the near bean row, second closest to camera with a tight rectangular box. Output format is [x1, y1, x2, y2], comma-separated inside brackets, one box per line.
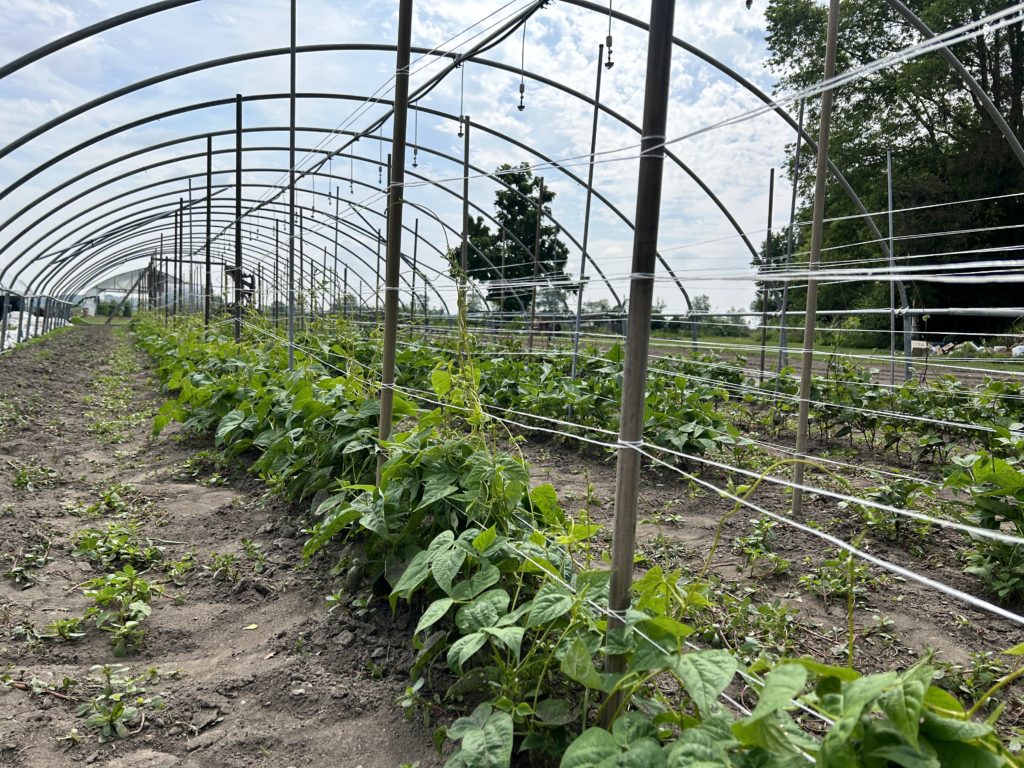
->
[377, 0, 413, 484]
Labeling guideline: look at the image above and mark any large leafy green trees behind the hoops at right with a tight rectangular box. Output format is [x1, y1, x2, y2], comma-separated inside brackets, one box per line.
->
[767, 0, 1024, 343]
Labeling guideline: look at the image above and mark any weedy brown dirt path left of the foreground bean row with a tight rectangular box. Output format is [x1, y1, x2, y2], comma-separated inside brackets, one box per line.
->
[0, 326, 440, 768]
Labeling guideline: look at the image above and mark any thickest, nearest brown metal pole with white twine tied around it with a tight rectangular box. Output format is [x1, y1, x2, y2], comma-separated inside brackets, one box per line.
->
[603, 0, 676, 725]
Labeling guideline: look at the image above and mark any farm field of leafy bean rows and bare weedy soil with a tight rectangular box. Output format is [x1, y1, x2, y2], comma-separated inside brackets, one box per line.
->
[0, 317, 1024, 766]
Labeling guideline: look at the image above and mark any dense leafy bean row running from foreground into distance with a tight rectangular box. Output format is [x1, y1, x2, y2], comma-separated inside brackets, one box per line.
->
[136, 318, 1024, 768]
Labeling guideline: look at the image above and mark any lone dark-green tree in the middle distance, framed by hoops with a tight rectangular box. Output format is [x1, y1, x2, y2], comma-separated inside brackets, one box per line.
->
[449, 163, 568, 312]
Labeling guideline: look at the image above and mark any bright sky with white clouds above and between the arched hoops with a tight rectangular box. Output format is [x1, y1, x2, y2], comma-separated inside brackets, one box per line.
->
[0, 0, 794, 312]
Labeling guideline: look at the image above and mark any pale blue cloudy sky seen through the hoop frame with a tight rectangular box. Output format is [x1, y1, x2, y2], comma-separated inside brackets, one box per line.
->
[0, 0, 793, 310]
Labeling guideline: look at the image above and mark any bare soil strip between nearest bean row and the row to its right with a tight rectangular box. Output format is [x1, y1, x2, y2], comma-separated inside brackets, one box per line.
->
[522, 439, 1024, 727]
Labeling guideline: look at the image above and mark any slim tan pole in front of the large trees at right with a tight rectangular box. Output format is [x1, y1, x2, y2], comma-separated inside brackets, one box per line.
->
[793, 0, 839, 516]
